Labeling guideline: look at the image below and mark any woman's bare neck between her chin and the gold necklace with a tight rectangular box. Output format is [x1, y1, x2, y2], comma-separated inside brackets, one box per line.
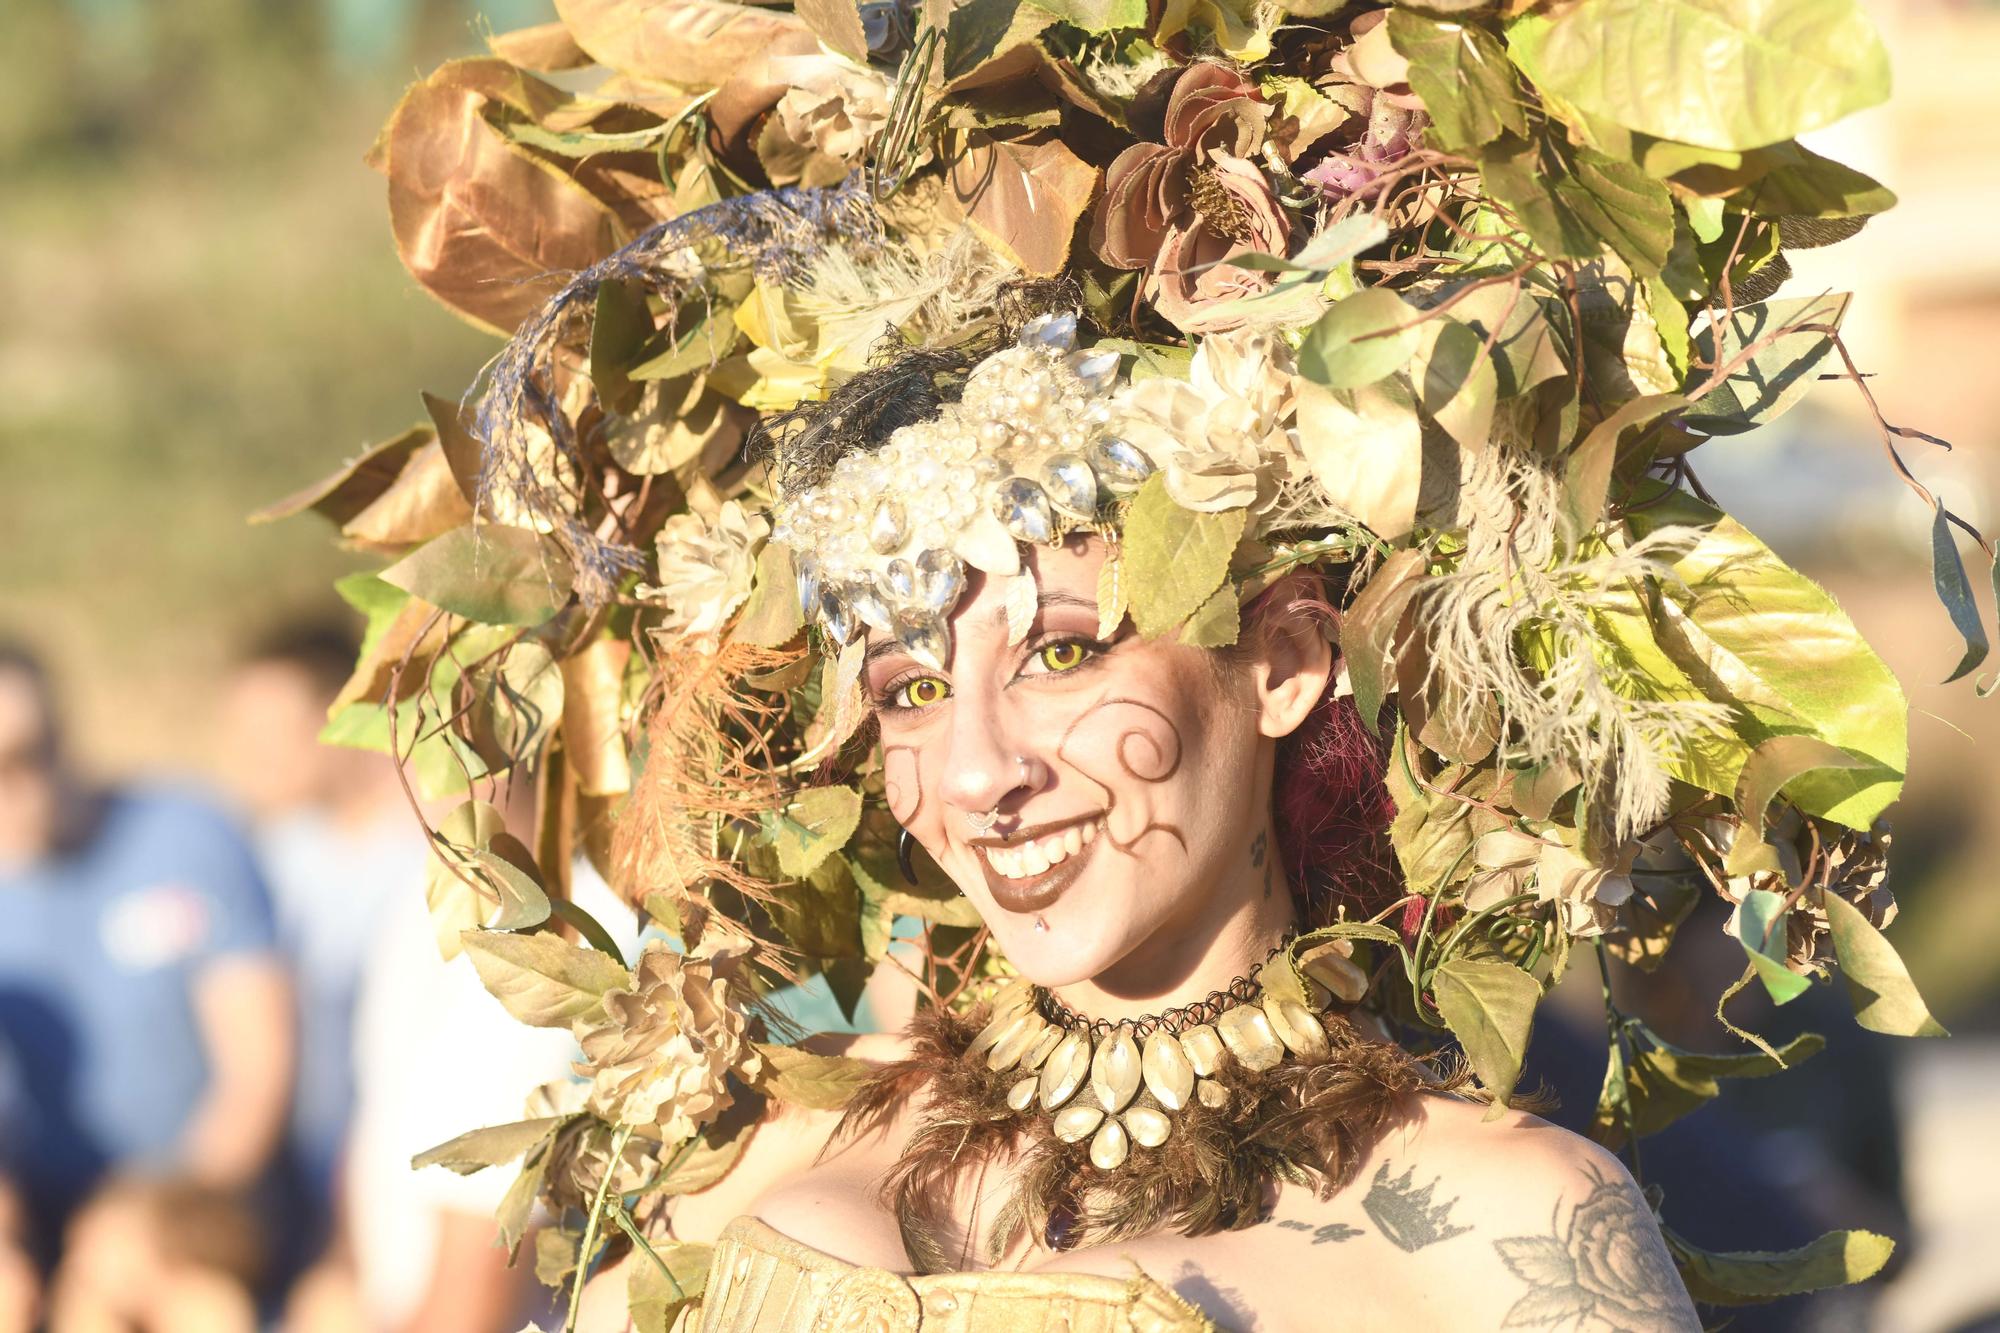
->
[1056, 825, 1298, 1023]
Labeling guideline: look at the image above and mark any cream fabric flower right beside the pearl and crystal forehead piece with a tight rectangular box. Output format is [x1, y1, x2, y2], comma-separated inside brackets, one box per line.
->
[1112, 330, 1298, 512]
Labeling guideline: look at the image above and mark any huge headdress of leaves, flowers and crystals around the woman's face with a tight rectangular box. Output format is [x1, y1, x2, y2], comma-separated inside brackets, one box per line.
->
[276, 0, 1990, 1309]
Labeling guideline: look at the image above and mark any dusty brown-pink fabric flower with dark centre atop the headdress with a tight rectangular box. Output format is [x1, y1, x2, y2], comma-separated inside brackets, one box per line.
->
[1092, 60, 1292, 332]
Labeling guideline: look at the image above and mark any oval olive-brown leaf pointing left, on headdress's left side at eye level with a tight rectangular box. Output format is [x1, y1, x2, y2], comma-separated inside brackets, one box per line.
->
[382, 522, 574, 624]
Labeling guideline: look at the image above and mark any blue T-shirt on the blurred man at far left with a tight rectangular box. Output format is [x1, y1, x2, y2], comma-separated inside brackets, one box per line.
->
[0, 791, 272, 1221]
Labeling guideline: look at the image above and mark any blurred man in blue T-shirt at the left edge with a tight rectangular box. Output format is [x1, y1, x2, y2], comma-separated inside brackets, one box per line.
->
[0, 642, 292, 1265]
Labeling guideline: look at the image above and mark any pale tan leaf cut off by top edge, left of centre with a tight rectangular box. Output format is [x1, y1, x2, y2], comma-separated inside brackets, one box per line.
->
[556, 0, 818, 92]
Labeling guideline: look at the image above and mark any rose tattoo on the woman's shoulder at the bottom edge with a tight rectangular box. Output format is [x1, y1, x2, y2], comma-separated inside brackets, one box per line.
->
[1494, 1175, 1702, 1333]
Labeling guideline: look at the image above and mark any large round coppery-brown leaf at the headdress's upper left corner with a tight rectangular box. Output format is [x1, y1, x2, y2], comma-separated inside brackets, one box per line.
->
[386, 71, 618, 334]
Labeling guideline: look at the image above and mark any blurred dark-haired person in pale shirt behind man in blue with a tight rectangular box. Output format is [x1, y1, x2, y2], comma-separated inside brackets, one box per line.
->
[220, 620, 426, 1269]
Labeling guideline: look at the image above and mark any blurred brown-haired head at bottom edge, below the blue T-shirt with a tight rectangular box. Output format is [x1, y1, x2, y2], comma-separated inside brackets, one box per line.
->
[48, 1177, 268, 1333]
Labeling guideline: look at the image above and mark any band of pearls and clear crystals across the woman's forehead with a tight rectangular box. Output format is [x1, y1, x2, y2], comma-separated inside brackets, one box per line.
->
[772, 314, 1154, 671]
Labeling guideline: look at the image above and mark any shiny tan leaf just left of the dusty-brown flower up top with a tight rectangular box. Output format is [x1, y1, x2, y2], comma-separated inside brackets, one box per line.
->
[952, 134, 1098, 278]
